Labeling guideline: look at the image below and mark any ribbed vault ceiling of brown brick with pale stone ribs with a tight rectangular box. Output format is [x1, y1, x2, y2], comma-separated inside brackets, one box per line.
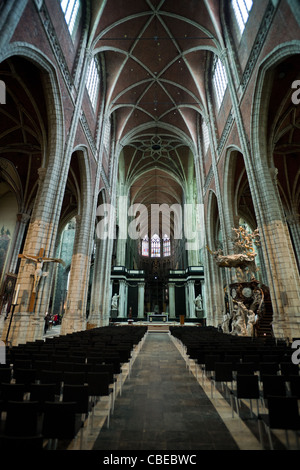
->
[91, 0, 220, 228]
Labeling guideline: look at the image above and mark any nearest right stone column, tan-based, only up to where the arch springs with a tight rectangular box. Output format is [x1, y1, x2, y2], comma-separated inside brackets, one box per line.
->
[256, 164, 300, 338]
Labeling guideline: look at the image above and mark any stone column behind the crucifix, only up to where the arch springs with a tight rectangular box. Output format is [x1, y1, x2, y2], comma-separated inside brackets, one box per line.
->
[2, 164, 61, 344]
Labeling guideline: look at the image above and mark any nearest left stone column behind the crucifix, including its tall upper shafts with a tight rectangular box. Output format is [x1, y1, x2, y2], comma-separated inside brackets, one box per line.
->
[0, 42, 95, 344]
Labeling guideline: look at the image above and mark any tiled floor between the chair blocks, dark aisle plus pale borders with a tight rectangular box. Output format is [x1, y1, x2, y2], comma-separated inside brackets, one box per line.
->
[62, 332, 296, 451]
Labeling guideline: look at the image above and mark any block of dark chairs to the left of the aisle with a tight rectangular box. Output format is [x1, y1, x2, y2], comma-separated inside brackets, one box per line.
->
[0, 327, 147, 449]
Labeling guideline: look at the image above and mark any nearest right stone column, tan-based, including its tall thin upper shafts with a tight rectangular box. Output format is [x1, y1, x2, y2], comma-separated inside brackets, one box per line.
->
[223, 46, 300, 338]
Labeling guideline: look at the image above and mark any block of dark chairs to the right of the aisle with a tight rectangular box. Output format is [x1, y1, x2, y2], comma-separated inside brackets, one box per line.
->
[170, 327, 300, 449]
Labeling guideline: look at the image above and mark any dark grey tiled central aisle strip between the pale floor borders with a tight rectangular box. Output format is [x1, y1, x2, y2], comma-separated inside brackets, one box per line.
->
[93, 333, 238, 451]
